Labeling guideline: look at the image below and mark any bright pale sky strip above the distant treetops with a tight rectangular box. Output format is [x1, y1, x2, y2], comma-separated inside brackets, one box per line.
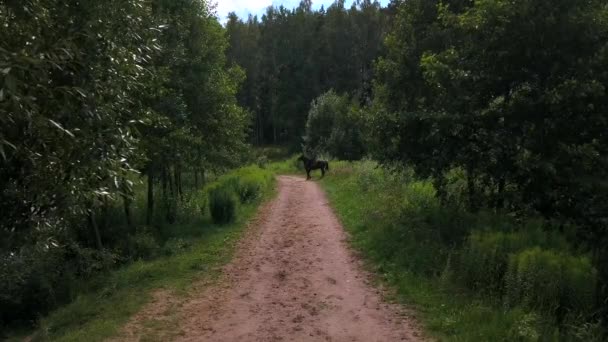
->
[212, 0, 389, 23]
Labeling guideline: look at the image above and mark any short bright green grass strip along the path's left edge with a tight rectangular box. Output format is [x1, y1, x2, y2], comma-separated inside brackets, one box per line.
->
[9, 166, 274, 341]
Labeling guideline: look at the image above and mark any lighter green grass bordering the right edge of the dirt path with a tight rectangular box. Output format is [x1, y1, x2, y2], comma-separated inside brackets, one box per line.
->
[320, 162, 600, 341]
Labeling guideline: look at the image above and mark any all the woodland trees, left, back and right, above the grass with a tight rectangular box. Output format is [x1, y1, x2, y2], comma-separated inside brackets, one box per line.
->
[0, 0, 608, 338]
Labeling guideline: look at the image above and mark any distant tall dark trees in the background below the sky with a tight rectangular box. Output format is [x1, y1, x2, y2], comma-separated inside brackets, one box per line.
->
[226, 0, 392, 147]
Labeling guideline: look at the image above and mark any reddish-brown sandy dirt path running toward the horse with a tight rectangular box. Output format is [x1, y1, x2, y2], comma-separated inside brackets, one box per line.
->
[117, 176, 420, 342]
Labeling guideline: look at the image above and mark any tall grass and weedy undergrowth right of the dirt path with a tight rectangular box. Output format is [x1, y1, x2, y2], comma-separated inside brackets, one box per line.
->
[321, 161, 602, 341]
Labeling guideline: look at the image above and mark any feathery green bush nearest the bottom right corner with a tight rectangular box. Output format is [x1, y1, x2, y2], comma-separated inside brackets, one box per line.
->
[505, 247, 597, 320]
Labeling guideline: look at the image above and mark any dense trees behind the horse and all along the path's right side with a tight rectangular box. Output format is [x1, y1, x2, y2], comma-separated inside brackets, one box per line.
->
[227, 0, 608, 334]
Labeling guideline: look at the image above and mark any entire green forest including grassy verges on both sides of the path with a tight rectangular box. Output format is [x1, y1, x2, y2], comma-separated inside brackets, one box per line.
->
[0, 0, 608, 341]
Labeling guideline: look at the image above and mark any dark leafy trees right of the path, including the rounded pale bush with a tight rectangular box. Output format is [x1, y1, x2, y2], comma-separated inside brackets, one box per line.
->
[294, 0, 608, 332]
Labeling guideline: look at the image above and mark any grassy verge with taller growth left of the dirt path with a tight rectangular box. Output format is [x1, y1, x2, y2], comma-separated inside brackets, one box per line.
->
[9, 166, 274, 341]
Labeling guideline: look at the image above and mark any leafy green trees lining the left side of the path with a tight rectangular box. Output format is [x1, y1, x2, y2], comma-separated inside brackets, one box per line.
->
[0, 0, 249, 326]
